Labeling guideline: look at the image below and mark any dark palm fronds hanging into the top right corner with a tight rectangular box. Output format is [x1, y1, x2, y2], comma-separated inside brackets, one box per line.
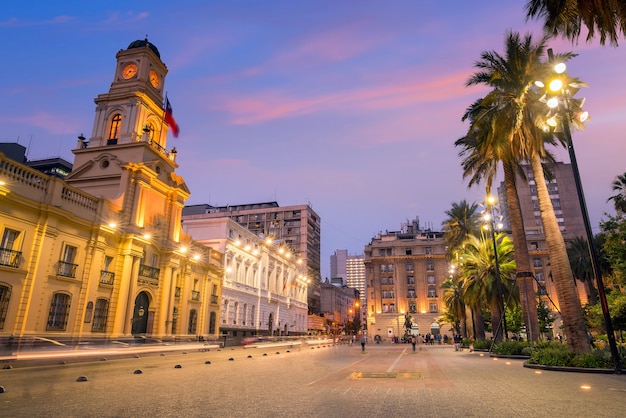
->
[526, 0, 626, 46]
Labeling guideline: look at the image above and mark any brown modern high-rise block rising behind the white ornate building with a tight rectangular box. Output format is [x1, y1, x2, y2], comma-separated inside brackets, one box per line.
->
[183, 202, 321, 314]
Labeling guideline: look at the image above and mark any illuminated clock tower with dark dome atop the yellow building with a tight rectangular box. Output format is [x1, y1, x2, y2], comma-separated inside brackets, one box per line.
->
[66, 39, 190, 242]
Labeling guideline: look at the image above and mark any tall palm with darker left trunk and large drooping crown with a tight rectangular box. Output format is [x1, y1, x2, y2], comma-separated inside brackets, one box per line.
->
[455, 32, 548, 341]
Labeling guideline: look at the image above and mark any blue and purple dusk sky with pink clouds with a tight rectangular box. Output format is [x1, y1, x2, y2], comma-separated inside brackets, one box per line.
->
[0, 0, 626, 278]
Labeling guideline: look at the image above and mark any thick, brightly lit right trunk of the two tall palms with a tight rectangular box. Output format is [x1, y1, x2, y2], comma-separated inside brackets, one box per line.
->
[531, 154, 591, 353]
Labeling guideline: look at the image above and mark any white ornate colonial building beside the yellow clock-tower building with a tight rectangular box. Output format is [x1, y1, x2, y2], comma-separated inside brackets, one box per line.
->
[183, 215, 308, 339]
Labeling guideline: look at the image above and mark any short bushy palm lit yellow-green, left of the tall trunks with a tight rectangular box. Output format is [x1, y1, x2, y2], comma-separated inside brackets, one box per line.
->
[459, 232, 515, 343]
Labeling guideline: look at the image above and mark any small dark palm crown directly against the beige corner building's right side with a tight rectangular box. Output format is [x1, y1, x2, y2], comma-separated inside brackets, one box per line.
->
[442, 199, 480, 259]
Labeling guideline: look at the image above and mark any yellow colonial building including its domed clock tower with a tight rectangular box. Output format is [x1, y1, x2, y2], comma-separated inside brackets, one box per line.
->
[0, 40, 223, 341]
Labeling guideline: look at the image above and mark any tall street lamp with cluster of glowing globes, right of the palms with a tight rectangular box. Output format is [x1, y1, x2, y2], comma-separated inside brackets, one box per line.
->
[535, 49, 622, 373]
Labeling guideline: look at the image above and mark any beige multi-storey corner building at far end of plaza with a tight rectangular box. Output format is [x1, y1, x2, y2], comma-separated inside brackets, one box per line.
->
[365, 220, 448, 338]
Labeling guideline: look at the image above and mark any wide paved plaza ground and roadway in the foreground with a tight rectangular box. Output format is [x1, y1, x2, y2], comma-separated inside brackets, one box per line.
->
[0, 344, 626, 418]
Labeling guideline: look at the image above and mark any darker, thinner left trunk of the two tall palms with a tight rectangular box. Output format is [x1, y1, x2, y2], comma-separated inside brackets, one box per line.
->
[502, 161, 539, 342]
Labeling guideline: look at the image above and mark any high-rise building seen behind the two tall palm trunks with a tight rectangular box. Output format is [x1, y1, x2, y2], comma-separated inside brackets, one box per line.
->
[498, 162, 589, 316]
